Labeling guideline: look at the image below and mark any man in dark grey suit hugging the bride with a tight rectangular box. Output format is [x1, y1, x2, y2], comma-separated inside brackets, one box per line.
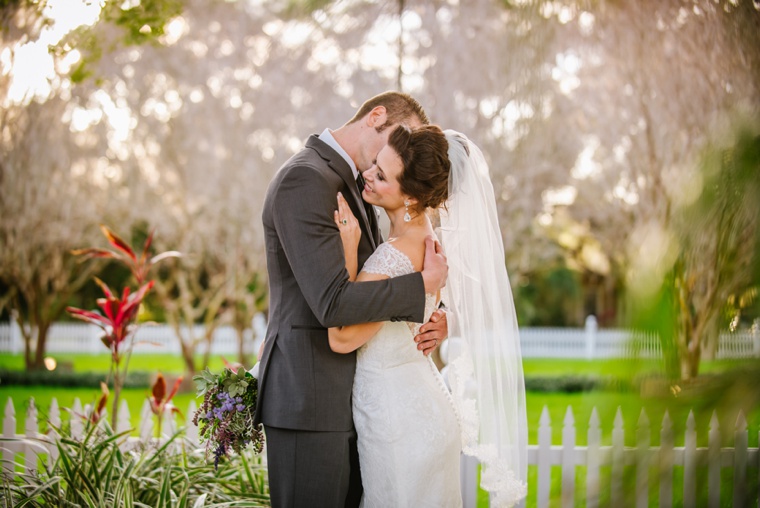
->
[256, 92, 448, 508]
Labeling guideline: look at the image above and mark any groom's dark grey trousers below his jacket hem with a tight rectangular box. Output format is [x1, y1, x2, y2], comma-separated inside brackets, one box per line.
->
[264, 426, 362, 508]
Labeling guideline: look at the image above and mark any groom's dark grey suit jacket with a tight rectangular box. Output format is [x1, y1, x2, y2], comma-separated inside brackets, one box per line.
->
[256, 136, 425, 431]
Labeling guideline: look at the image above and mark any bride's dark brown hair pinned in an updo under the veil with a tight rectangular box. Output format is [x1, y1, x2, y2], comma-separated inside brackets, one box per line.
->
[388, 125, 451, 213]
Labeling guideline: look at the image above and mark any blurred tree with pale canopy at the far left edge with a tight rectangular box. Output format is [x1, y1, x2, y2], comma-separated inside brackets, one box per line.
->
[0, 94, 101, 369]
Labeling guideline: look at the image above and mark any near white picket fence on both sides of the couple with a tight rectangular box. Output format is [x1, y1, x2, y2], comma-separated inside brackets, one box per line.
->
[0, 398, 760, 508]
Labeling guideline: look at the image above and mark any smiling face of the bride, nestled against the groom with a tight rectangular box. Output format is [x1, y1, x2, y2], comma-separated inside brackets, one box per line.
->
[362, 145, 404, 210]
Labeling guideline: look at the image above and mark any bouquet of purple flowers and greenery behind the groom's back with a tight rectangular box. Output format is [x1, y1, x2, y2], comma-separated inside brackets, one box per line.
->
[193, 367, 264, 467]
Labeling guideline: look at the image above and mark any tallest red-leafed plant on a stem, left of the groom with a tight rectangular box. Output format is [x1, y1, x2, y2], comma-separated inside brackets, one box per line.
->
[66, 226, 180, 428]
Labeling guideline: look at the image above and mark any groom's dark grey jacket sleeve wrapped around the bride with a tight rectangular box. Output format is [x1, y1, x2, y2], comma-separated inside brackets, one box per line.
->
[273, 167, 425, 328]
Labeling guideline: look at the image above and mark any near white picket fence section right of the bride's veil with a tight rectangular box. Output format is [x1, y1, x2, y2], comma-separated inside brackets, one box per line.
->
[528, 406, 760, 508]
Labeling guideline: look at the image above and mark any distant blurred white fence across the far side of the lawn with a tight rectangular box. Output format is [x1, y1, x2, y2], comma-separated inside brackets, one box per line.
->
[0, 315, 760, 360]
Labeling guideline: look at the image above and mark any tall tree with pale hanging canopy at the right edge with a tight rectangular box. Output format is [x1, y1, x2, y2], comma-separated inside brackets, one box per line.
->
[570, 1, 760, 379]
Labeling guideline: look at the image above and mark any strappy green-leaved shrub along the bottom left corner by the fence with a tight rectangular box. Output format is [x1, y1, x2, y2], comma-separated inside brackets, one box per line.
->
[0, 421, 269, 507]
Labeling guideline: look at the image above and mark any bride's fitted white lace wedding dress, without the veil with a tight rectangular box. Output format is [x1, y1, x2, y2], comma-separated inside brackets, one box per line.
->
[353, 243, 462, 508]
